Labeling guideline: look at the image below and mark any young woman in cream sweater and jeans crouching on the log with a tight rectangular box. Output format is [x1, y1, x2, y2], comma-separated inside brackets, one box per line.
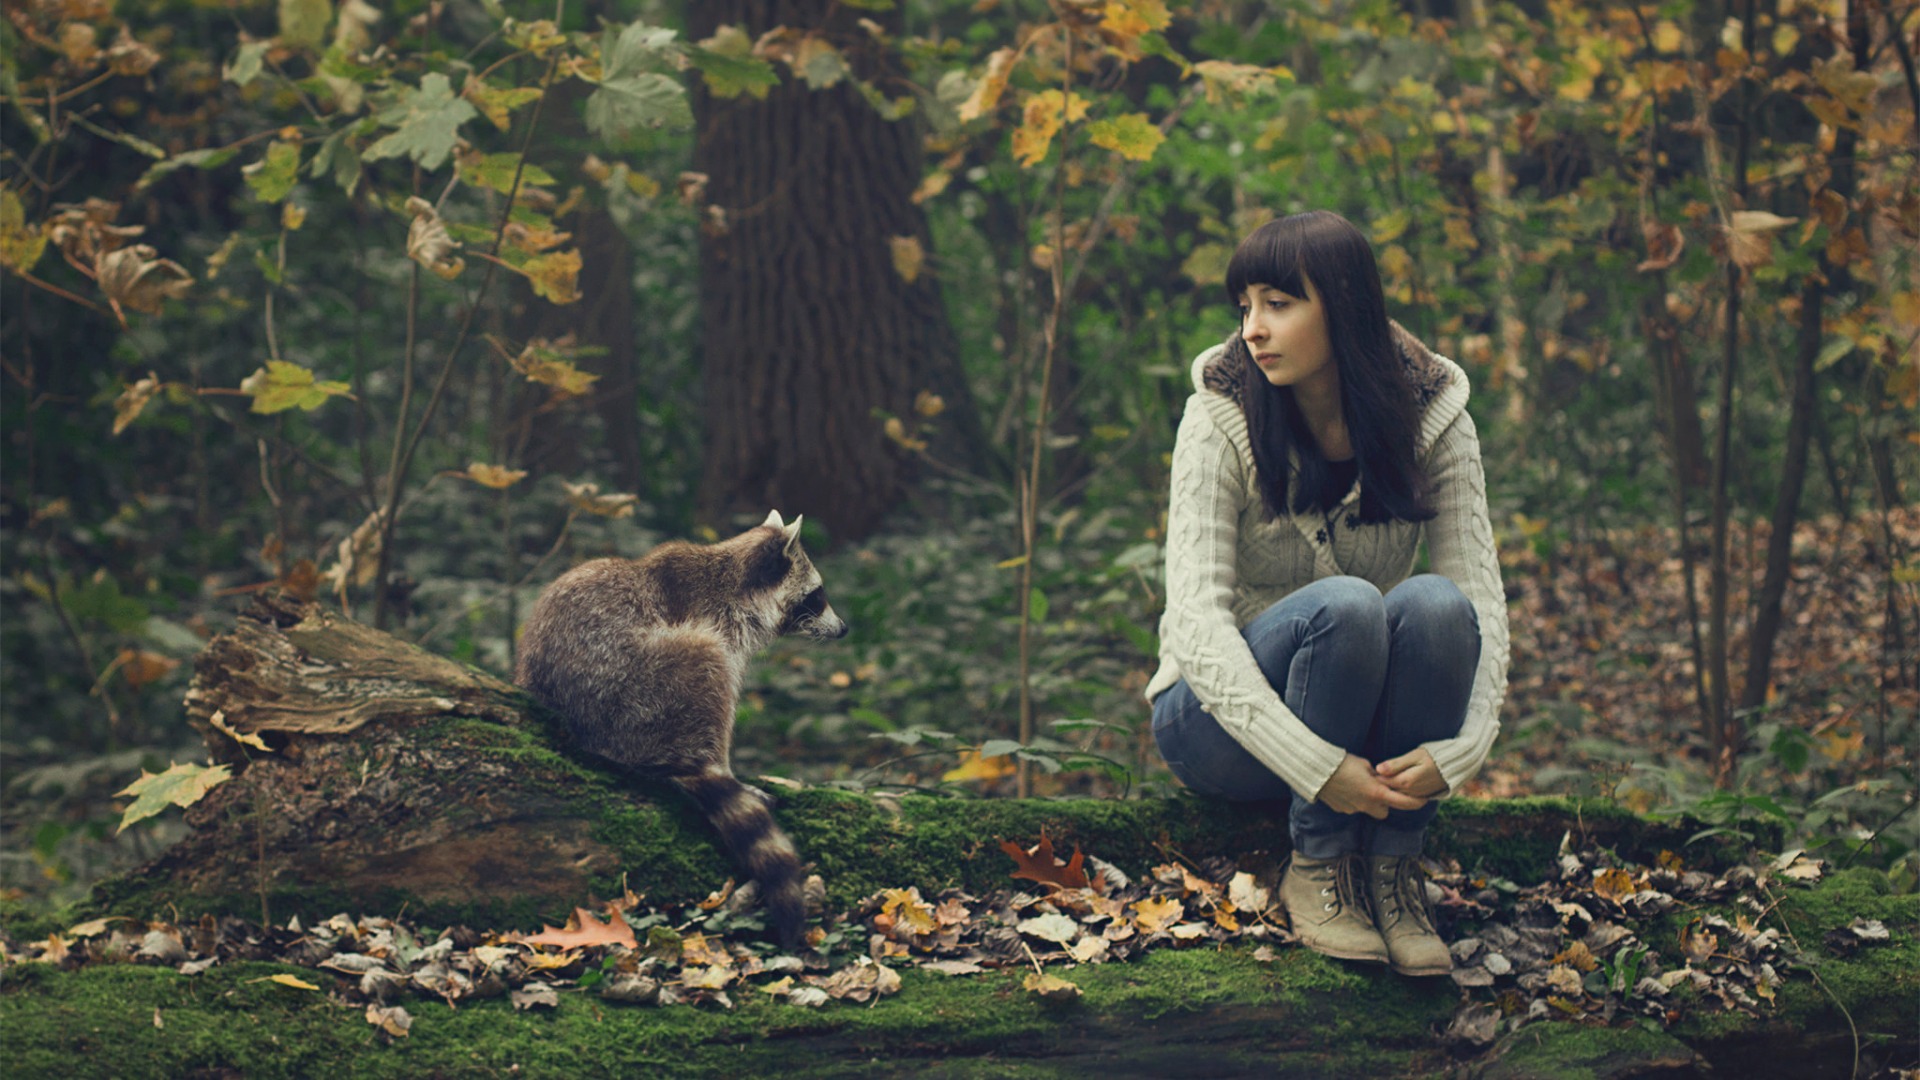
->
[1146, 211, 1507, 974]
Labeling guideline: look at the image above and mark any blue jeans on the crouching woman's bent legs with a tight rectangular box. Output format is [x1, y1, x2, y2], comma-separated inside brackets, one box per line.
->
[1154, 575, 1480, 859]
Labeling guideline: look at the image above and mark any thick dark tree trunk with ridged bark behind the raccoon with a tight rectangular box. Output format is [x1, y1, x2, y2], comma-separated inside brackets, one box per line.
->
[687, 0, 979, 538]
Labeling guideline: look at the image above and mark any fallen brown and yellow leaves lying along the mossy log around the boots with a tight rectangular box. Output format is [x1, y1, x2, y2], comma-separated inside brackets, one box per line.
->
[0, 822, 1891, 1051]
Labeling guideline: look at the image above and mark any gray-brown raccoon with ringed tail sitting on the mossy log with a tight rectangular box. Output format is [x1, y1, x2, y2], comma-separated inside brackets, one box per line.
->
[513, 511, 847, 945]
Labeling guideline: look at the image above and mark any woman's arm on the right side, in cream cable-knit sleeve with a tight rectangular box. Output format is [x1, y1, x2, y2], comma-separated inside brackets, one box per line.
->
[1421, 409, 1507, 792]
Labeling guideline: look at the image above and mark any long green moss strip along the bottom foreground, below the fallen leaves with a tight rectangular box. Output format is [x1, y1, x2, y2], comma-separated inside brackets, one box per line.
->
[0, 949, 1453, 1078]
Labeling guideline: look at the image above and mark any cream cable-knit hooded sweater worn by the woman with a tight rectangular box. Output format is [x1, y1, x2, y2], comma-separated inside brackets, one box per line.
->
[1146, 325, 1507, 798]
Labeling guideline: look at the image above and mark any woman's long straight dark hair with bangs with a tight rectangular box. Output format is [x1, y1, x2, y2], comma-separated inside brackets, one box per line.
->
[1227, 209, 1434, 525]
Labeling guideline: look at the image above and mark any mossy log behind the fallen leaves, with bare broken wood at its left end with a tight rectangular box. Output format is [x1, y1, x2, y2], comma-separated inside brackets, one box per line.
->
[98, 588, 1743, 926]
